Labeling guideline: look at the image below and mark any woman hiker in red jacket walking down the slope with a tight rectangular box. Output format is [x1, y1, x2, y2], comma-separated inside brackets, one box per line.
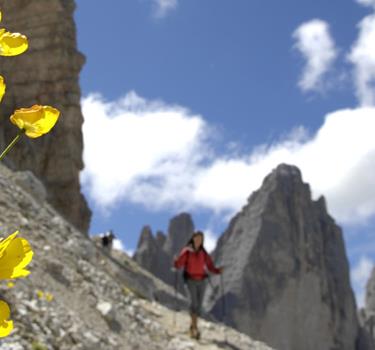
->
[173, 231, 223, 339]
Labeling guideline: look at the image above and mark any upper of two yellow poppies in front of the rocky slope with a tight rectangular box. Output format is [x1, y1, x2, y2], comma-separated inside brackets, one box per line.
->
[0, 231, 33, 279]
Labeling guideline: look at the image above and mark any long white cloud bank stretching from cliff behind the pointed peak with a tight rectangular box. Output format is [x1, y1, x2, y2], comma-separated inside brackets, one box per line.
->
[81, 92, 375, 223]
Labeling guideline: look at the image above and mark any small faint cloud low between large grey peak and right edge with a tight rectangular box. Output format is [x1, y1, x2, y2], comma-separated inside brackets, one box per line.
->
[350, 256, 374, 307]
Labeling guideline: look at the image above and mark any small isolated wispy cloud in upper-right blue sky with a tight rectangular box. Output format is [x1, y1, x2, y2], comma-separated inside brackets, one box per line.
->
[293, 19, 337, 91]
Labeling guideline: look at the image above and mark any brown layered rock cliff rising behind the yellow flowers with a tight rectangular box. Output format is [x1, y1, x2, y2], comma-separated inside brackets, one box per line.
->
[0, 0, 91, 232]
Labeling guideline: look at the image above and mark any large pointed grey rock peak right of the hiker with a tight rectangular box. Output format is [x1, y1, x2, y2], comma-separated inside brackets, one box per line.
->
[205, 164, 360, 350]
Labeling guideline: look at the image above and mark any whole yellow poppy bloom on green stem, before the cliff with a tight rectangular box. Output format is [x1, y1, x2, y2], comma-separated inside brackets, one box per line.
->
[10, 105, 60, 138]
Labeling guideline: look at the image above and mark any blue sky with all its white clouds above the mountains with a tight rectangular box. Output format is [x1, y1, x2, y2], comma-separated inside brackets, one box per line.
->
[75, 0, 375, 306]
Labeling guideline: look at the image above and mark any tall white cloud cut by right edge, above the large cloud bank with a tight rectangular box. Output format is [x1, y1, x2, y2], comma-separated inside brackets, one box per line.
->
[348, 13, 375, 106]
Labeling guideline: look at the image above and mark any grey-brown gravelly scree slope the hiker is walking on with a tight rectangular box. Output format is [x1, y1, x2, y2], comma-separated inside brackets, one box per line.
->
[0, 165, 270, 350]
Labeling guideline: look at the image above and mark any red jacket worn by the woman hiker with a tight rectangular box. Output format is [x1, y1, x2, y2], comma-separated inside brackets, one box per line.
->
[173, 247, 220, 280]
